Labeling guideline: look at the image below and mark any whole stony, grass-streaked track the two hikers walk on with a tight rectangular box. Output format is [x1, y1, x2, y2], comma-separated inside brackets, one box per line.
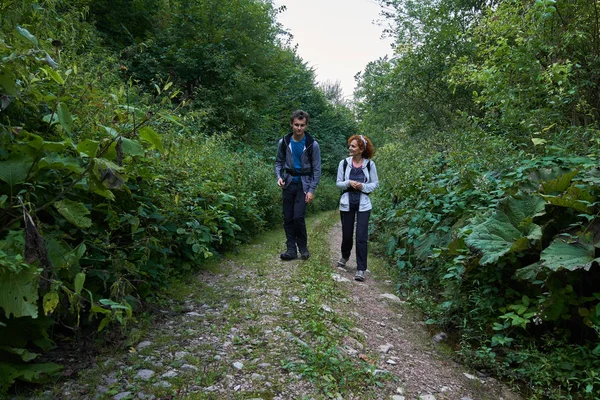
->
[13, 214, 519, 400]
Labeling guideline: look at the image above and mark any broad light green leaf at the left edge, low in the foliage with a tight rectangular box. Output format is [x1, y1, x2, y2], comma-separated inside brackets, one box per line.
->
[0, 266, 39, 318]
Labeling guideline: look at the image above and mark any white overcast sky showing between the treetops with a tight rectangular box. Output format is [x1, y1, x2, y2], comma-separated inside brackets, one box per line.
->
[273, 0, 392, 99]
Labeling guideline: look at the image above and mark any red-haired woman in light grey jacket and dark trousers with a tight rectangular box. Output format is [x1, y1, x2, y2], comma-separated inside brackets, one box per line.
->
[336, 135, 379, 282]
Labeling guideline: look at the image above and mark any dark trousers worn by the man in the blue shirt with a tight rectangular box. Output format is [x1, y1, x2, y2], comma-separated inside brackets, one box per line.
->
[283, 182, 307, 254]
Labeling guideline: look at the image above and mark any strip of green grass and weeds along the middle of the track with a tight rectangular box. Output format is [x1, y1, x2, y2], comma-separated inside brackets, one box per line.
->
[282, 213, 389, 398]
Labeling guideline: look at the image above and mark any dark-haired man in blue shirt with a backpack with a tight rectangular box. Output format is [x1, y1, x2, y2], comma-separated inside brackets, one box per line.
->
[275, 110, 321, 260]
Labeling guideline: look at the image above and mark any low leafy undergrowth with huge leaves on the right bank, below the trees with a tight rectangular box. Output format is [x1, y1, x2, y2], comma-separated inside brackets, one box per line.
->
[374, 128, 600, 398]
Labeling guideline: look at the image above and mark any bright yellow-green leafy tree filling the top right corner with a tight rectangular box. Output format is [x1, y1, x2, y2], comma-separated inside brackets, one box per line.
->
[454, 0, 600, 151]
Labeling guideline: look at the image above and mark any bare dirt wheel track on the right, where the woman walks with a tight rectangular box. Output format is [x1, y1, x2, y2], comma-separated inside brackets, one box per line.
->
[329, 219, 520, 400]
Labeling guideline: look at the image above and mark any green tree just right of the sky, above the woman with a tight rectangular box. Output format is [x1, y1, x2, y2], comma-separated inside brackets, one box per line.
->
[356, 0, 488, 141]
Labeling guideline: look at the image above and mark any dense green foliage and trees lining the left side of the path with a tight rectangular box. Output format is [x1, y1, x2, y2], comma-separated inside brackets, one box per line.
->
[0, 0, 355, 393]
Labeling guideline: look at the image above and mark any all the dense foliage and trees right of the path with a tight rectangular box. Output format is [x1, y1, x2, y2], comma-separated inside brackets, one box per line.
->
[356, 0, 600, 399]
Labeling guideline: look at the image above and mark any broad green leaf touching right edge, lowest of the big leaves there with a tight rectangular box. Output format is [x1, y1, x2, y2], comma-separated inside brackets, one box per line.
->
[540, 233, 600, 271]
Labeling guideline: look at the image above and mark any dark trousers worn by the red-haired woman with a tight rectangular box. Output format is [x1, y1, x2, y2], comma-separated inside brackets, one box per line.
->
[340, 208, 371, 271]
